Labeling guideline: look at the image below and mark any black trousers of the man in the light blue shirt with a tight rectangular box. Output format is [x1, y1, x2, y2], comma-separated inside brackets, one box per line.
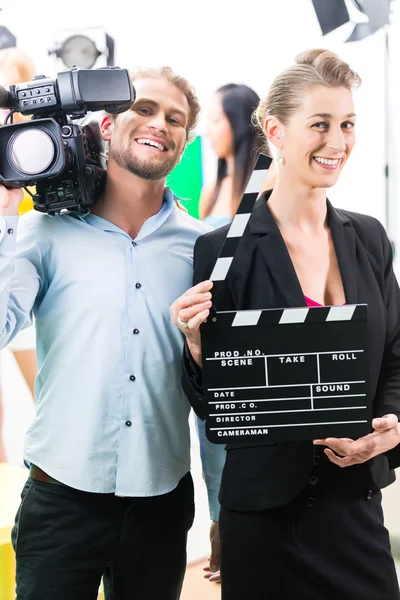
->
[12, 473, 194, 600]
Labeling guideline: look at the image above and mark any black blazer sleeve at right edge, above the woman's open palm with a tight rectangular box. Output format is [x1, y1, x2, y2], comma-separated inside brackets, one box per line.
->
[376, 225, 400, 469]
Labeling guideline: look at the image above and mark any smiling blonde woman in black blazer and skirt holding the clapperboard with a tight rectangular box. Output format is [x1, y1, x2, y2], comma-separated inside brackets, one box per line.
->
[171, 50, 400, 600]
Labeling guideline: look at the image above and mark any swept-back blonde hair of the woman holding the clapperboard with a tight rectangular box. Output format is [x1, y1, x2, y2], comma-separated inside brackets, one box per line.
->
[253, 49, 361, 154]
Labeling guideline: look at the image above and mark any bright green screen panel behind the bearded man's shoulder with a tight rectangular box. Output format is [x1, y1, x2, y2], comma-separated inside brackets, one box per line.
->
[167, 136, 203, 218]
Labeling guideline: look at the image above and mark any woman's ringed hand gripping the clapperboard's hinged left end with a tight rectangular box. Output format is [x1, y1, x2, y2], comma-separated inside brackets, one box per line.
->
[170, 281, 213, 367]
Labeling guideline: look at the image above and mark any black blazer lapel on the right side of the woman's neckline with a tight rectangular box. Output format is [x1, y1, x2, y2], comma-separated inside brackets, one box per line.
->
[327, 200, 357, 304]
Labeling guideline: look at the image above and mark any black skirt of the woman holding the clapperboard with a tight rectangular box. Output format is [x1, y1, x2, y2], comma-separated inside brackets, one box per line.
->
[220, 449, 400, 600]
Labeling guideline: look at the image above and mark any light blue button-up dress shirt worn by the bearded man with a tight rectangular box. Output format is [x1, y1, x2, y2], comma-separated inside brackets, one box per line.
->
[0, 190, 219, 519]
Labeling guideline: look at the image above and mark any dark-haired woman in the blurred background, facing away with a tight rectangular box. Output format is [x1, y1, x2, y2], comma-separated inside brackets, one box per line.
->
[199, 83, 261, 229]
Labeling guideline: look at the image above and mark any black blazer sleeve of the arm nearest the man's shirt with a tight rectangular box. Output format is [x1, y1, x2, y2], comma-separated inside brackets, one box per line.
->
[182, 232, 234, 421]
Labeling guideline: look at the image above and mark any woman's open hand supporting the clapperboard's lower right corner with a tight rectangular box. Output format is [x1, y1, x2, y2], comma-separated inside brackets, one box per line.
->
[314, 415, 400, 467]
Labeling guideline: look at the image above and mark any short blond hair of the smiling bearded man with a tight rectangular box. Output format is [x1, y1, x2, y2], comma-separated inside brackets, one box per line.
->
[131, 67, 200, 141]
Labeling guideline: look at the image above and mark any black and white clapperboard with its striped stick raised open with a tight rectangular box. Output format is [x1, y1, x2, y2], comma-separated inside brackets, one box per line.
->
[201, 155, 372, 445]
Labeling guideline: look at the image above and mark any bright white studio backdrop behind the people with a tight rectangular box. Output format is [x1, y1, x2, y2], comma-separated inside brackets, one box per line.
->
[0, 0, 400, 247]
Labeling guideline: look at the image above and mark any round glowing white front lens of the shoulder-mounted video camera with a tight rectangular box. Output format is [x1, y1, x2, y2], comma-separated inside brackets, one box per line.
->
[7, 127, 56, 175]
